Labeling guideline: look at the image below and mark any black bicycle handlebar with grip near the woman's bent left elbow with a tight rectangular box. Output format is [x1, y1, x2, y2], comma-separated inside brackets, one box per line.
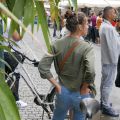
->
[9, 44, 39, 67]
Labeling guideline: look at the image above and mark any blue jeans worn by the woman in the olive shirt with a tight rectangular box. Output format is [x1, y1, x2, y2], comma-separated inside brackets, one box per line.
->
[52, 86, 90, 120]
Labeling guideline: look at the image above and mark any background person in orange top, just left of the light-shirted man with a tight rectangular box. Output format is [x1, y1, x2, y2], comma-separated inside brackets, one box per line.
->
[96, 12, 103, 44]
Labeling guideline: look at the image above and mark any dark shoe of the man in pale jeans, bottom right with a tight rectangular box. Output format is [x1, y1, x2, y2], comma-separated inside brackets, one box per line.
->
[101, 106, 119, 117]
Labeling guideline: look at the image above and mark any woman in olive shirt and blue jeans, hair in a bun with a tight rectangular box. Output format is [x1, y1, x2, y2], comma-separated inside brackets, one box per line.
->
[38, 13, 95, 120]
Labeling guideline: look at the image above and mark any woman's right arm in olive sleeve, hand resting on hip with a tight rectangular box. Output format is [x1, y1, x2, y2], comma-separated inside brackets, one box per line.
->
[80, 47, 95, 94]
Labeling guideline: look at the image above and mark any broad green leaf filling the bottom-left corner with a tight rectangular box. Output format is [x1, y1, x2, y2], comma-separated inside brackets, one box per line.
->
[0, 73, 20, 120]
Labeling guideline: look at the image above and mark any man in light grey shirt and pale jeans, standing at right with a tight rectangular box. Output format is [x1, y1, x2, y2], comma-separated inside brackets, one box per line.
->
[99, 6, 120, 117]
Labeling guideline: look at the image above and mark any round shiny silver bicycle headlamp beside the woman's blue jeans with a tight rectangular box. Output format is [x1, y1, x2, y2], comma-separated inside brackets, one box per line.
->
[80, 98, 100, 118]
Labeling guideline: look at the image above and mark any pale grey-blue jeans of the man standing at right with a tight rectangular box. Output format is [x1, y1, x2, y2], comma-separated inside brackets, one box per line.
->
[100, 64, 117, 108]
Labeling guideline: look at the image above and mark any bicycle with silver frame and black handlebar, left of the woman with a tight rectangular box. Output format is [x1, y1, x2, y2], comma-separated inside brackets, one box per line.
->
[5, 45, 55, 120]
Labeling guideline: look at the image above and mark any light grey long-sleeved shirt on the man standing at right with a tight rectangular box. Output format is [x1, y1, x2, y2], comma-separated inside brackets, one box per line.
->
[100, 20, 120, 65]
